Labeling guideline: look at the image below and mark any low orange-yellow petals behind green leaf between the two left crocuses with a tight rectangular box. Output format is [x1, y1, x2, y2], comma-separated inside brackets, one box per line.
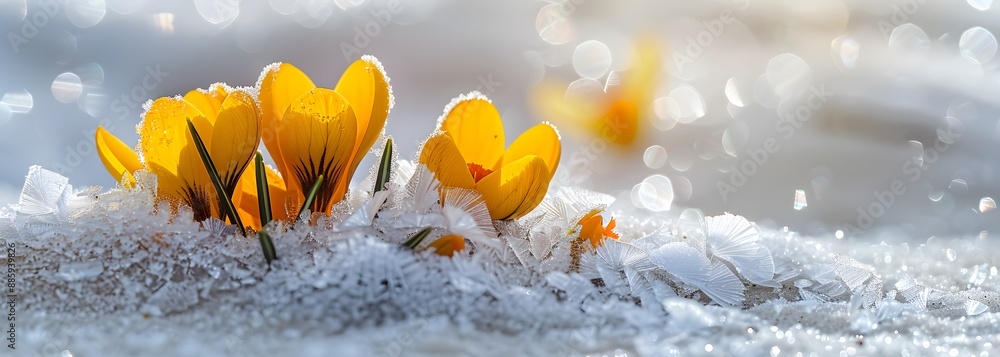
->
[233, 166, 298, 231]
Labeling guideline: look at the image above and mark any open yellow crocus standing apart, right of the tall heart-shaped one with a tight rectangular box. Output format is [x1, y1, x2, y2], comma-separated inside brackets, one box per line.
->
[420, 92, 562, 220]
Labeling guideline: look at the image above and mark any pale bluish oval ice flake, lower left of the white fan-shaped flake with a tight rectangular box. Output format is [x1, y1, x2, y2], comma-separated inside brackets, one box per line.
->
[649, 242, 712, 288]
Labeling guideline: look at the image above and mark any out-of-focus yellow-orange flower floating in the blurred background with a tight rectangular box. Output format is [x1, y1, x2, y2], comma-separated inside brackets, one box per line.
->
[531, 38, 662, 145]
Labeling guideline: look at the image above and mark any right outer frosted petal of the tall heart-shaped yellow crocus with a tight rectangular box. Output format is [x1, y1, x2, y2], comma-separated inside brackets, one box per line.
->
[334, 56, 392, 195]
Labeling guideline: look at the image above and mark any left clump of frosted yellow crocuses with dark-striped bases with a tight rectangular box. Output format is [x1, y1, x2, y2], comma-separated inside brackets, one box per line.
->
[96, 56, 392, 229]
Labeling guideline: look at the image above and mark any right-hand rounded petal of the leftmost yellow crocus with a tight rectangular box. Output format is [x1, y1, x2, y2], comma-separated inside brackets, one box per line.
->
[209, 91, 263, 195]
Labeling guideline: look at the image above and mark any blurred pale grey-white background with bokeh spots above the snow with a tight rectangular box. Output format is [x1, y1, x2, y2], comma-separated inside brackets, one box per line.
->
[0, 0, 1000, 240]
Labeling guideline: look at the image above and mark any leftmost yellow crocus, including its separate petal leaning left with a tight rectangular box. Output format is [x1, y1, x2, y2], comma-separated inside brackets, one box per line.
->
[97, 84, 263, 221]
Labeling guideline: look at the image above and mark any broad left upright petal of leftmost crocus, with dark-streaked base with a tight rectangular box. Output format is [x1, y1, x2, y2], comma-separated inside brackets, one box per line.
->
[137, 98, 219, 220]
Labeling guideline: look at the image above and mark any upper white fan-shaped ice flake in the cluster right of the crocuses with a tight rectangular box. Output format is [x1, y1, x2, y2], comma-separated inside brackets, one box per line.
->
[705, 213, 760, 262]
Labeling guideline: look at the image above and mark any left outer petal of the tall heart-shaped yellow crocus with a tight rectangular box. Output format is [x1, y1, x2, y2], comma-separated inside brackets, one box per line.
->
[257, 63, 316, 182]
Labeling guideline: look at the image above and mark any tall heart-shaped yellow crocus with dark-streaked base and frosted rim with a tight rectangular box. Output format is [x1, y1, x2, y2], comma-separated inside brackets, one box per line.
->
[258, 56, 392, 216]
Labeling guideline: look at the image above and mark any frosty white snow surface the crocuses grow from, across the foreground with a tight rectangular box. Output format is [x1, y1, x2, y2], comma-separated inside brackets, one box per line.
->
[0, 165, 1000, 356]
